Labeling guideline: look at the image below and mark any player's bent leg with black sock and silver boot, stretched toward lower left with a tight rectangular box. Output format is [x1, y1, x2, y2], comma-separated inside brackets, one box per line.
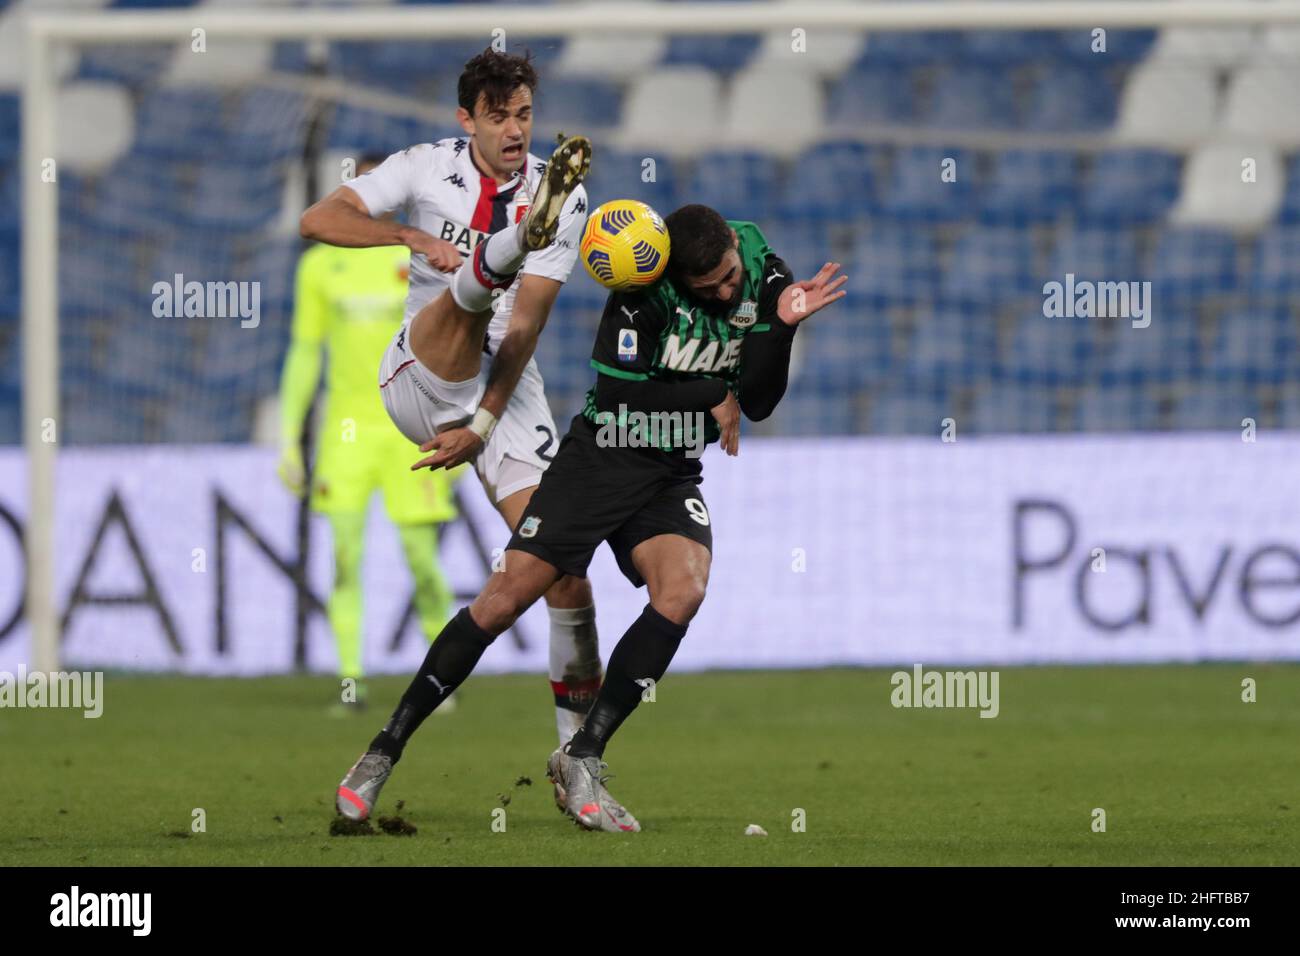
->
[335, 551, 560, 819]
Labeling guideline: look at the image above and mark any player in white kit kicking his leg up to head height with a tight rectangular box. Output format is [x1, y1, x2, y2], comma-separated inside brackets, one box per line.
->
[300, 49, 629, 816]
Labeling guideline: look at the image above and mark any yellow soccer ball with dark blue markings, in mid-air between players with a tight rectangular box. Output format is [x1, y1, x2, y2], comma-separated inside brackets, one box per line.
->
[579, 199, 668, 289]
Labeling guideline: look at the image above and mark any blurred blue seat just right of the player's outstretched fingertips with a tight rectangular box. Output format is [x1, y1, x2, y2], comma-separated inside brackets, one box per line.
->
[847, 225, 939, 311]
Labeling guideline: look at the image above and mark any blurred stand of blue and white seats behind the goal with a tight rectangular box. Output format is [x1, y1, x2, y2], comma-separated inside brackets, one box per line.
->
[0, 0, 1300, 445]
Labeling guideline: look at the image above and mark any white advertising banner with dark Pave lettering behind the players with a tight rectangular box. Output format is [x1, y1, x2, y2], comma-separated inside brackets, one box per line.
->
[0, 433, 1300, 675]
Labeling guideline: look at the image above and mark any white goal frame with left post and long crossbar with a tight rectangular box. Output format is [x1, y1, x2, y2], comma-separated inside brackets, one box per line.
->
[21, 0, 1300, 672]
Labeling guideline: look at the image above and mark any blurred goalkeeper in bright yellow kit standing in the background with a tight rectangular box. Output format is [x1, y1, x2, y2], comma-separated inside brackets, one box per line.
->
[280, 156, 456, 713]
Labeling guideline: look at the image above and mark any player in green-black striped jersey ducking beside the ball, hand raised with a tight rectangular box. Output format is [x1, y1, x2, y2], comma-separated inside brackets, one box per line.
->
[337, 206, 846, 831]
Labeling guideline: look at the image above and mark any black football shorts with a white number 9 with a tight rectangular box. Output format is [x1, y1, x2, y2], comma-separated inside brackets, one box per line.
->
[507, 416, 714, 588]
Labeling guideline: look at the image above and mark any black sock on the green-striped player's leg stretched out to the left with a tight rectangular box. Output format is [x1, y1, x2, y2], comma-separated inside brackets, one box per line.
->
[371, 607, 495, 763]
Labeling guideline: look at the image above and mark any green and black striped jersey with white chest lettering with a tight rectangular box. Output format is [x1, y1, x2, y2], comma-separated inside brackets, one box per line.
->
[581, 221, 794, 451]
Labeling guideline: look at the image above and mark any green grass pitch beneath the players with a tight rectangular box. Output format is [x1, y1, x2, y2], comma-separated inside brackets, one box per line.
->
[0, 663, 1300, 866]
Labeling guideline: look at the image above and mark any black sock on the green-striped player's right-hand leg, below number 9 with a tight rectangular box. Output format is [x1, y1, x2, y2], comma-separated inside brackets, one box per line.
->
[568, 605, 686, 757]
